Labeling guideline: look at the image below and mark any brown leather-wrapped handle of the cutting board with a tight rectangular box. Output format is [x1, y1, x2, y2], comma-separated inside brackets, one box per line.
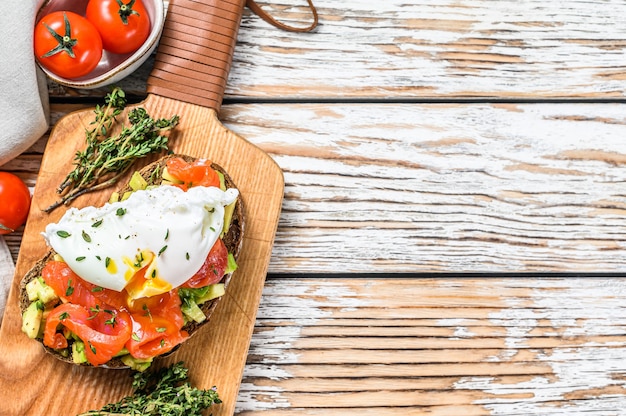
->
[147, 0, 245, 112]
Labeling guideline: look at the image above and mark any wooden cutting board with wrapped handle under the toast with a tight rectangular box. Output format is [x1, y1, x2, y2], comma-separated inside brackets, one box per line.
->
[0, 0, 284, 416]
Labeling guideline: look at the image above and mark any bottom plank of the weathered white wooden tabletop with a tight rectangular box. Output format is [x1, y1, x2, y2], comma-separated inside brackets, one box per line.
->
[237, 276, 626, 416]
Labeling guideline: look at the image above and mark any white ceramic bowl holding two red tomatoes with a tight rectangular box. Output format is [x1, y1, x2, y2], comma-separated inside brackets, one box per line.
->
[36, 0, 165, 89]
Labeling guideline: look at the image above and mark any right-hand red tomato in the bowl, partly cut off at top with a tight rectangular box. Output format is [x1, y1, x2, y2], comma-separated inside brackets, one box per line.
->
[85, 0, 151, 54]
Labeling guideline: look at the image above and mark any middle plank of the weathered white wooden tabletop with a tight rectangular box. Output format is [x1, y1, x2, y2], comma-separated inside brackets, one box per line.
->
[7, 104, 626, 273]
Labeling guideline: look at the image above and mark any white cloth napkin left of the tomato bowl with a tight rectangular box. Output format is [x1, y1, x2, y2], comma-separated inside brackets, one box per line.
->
[0, 0, 49, 166]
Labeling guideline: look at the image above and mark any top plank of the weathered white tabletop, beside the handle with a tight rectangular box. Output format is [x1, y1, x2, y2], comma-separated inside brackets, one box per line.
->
[47, 0, 626, 100]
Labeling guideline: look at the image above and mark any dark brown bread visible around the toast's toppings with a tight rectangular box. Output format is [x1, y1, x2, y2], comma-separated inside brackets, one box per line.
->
[19, 154, 244, 368]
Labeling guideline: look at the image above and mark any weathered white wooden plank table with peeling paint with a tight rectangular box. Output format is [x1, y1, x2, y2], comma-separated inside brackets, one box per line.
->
[3, 0, 626, 416]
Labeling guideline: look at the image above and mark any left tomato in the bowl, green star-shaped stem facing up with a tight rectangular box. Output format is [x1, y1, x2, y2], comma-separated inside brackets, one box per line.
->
[33, 11, 102, 79]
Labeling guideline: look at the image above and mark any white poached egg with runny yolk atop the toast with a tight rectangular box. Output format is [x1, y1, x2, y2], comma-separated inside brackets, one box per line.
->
[42, 185, 238, 299]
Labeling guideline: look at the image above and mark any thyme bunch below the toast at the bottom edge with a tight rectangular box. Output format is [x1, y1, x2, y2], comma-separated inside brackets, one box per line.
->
[78, 362, 222, 416]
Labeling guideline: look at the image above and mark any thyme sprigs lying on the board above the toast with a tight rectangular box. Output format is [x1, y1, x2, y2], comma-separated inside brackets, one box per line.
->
[44, 88, 179, 212]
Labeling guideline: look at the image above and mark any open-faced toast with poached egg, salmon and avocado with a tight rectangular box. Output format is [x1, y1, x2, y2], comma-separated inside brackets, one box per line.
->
[20, 155, 244, 371]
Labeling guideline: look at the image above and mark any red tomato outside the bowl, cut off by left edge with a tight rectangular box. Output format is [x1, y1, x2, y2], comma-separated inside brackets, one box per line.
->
[0, 172, 30, 234]
